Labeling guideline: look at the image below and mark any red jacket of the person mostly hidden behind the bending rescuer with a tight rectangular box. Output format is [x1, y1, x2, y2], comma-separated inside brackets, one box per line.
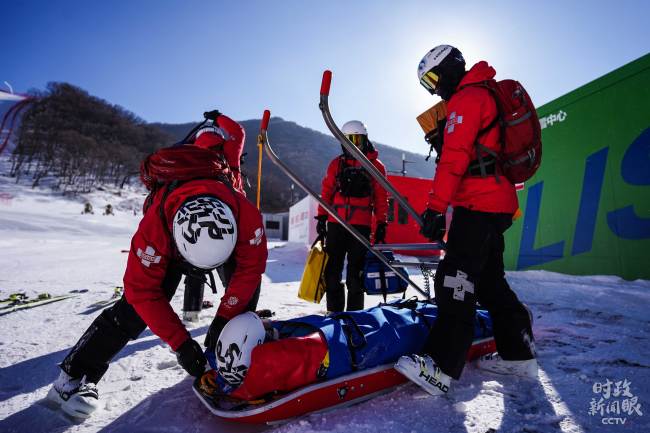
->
[194, 114, 246, 195]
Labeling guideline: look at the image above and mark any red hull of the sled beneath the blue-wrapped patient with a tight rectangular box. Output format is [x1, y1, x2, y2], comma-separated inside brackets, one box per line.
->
[193, 337, 496, 424]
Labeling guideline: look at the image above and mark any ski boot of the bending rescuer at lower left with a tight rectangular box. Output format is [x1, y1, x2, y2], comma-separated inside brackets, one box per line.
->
[47, 371, 99, 419]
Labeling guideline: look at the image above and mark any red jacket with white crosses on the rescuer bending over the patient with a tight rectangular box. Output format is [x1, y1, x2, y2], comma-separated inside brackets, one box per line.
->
[124, 179, 267, 350]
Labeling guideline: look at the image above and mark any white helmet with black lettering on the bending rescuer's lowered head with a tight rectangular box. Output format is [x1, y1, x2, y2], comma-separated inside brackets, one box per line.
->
[173, 196, 237, 269]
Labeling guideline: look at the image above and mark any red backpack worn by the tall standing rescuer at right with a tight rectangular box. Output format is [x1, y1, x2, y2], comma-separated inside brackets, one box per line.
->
[471, 80, 542, 183]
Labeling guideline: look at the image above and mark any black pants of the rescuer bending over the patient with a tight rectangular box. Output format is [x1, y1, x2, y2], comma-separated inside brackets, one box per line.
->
[60, 256, 260, 383]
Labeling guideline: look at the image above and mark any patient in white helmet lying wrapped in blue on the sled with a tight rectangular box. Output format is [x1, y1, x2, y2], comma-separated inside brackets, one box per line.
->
[198, 299, 494, 401]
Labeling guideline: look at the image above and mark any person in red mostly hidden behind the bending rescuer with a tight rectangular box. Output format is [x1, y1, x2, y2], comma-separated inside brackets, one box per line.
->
[194, 110, 246, 195]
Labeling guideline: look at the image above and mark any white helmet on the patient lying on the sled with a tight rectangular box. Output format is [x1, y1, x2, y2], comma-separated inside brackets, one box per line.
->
[216, 311, 265, 386]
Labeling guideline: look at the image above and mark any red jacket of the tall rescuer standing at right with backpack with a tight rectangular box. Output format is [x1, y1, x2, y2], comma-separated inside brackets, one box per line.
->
[427, 61, 518, 213]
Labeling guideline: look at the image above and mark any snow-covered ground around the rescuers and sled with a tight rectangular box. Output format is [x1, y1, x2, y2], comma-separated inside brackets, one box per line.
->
[0, 170, 650, 433]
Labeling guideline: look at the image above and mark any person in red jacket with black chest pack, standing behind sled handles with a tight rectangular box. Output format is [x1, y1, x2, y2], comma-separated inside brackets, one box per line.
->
[316, 120, 388, 312]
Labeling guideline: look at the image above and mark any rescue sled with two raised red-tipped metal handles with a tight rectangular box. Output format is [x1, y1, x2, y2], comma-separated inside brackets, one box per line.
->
[193, 76, 496, 424]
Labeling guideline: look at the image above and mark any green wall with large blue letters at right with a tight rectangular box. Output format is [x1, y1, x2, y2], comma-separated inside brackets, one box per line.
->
[505, 54, 650, 279]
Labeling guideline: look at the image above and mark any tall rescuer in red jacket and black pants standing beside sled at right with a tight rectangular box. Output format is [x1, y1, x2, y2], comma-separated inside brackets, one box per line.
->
[395, 45, 537, 395]
